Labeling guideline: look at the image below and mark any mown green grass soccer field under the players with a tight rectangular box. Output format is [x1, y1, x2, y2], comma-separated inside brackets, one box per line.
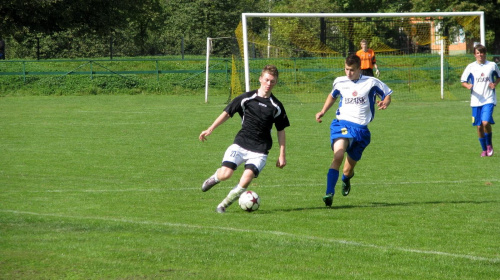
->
[0, 95, 500, 280]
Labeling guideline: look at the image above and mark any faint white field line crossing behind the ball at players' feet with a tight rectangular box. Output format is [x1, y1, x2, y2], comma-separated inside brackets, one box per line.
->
[3, 178, 500, 193]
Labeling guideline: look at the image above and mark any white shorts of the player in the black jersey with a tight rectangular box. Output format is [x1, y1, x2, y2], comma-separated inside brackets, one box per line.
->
[222, 144, 267, 177]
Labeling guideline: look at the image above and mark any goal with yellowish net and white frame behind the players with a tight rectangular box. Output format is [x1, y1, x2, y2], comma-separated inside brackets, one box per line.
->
[231, 12, 484, 102]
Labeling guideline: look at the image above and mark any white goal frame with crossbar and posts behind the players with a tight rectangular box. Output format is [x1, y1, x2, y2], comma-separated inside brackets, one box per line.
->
[241, 11, 485, 99]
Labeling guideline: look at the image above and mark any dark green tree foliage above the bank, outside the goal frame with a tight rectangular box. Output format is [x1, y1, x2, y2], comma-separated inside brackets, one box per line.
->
[0, 0, 500, 58]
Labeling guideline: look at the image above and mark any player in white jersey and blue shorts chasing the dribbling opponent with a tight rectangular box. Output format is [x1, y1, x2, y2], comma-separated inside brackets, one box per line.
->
[316, 54, 392, 207]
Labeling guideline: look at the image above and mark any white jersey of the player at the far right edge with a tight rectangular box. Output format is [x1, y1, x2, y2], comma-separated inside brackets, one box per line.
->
[460, 61, 500, 107]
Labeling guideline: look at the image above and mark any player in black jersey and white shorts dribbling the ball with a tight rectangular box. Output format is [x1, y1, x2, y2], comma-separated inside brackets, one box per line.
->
[199, 65, 290, 213]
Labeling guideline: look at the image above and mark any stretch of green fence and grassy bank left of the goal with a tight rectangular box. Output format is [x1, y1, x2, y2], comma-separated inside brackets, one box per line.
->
[0, 58, 231, 95]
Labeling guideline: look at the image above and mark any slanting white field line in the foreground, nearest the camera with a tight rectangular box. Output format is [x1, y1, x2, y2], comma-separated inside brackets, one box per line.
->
[0, 209, 500, 263]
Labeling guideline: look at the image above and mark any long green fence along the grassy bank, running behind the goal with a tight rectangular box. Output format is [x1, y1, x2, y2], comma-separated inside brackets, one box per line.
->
[0, 55, 493, 102]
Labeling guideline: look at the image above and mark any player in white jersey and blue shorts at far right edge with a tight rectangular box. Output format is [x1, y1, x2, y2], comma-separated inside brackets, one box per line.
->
[460, 44, 500, 157]
